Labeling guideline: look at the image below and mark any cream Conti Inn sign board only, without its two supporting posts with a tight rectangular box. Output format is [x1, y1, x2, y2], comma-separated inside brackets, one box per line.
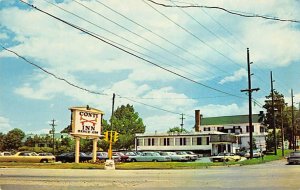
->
[70, 106, 103, 137]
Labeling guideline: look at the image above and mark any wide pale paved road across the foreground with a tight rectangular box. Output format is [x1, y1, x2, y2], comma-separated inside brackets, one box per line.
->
[0, 160, 300, 190]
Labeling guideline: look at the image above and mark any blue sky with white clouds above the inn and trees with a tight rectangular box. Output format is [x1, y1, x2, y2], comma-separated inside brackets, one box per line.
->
[0, 0, 300, 134]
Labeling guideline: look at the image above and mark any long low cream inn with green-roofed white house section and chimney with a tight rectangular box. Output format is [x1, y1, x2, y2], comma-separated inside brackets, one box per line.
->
[135, 110, 267, 156]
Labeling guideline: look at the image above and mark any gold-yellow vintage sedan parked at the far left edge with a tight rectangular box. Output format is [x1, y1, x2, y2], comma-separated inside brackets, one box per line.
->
[0, 151, 55, 163]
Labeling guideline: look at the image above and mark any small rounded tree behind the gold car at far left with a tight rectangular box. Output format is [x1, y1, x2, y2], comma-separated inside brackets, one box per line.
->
[3, 128, 25, 150]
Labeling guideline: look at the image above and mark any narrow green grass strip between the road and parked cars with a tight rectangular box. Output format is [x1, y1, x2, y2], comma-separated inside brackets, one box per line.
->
[0, 150, 291, 170]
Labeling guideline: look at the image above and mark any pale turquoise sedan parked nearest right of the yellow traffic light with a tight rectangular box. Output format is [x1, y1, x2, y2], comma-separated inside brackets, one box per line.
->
[128, 152, 171, 162]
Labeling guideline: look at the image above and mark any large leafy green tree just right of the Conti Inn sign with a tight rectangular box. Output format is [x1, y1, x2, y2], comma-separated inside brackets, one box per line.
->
[102, 104, 146, 149]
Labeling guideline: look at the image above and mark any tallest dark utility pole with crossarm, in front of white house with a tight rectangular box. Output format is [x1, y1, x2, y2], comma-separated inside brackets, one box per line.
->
[241, 48, 259, 159]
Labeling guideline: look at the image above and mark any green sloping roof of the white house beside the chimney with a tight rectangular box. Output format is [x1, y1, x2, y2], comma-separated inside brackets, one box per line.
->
[201, 114, 260, 125]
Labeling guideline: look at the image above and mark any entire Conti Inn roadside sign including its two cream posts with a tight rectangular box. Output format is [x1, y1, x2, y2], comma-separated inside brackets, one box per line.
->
[69, 106, 104, 163]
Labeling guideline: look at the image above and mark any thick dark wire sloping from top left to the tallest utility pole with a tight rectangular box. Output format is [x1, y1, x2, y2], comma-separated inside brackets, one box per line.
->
[20, 0, 245, 99]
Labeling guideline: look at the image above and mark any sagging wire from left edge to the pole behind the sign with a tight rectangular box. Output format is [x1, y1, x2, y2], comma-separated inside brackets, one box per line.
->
[0, 45, 108, 96]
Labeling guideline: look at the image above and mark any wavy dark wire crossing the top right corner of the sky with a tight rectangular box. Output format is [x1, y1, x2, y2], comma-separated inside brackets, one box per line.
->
[147, 0, 300, 23]
